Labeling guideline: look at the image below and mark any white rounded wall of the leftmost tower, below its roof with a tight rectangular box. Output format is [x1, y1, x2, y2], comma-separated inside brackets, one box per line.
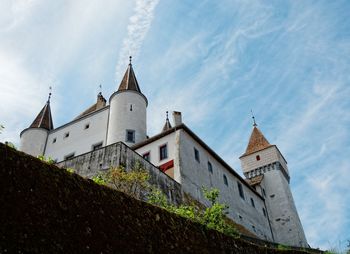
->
[20, 128, 49, 157]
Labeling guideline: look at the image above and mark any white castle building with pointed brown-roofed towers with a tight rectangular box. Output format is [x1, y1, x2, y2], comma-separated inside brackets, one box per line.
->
[20, 59, 308, 247]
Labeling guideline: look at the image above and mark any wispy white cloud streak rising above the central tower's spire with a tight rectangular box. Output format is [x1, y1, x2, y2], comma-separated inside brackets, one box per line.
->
[116, 0, 159, 81]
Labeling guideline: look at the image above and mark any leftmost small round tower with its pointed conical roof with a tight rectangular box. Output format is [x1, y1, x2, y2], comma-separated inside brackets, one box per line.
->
[20, 93, 53, 157]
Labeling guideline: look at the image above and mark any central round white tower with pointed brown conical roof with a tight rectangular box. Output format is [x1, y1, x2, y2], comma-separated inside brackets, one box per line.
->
[107, 57, 148, 146]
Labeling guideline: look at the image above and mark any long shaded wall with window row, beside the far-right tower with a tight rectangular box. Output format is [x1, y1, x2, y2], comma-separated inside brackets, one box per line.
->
[178, 130, 272, 240]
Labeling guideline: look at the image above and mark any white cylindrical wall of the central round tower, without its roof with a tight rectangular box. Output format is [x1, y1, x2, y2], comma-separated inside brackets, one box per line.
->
[107, 90, 147, 146]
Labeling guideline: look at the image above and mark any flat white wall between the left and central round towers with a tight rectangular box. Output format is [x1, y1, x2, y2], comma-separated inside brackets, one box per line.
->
[45, 106, 109, 161]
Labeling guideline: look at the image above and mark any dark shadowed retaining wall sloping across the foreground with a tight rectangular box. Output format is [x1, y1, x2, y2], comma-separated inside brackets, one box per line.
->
[0, 143, 322, 254]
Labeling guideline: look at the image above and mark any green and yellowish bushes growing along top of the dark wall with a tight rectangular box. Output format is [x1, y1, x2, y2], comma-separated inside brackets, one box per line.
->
[92, 164, 238, 237]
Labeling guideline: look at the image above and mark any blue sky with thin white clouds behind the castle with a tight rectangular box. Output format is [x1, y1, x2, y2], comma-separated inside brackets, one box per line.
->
[0, 0, 350, 250]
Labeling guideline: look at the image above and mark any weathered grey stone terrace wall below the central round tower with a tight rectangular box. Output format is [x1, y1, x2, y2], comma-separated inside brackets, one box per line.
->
[57, 142, 182, 204]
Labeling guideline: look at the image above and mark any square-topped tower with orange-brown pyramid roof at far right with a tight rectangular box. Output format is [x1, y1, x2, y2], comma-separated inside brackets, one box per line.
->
[240, 123, 308, 247]
